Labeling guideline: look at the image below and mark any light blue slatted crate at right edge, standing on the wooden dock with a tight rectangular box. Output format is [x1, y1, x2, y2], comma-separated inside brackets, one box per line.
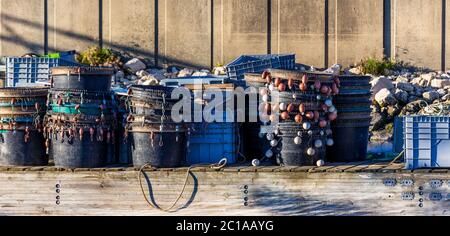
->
[403, 116, 450, 169]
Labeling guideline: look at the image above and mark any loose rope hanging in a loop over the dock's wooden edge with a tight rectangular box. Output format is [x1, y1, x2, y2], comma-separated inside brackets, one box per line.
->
[138, 158, 227, 212]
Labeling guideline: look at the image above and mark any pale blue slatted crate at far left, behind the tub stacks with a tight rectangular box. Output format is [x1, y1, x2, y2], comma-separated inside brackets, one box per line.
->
[6, 57, 78, 87]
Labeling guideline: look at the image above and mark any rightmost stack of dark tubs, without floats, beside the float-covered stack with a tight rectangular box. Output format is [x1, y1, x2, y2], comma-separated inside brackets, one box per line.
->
[327, 76, 371, 162]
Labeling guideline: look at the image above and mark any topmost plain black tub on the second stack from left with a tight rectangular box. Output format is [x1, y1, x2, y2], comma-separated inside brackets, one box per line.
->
[51, 66, 114, 92]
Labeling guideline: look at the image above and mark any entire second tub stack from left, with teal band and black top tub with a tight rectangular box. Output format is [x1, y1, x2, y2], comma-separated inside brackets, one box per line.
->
[44, 67, 117, 168]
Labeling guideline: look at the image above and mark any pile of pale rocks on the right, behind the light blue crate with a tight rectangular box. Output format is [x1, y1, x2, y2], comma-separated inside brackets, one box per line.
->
[371, 70, 450, 139]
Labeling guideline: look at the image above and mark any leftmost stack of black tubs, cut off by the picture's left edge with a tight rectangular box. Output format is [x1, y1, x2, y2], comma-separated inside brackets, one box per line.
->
[0, 88, 48, 166]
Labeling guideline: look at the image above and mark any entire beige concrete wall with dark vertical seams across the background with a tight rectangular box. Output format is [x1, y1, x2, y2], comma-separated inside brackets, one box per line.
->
[0, 0, 450, 69]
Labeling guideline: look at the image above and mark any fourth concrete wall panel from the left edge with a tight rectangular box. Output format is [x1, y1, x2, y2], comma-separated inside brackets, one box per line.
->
[158, 0, 212, 68]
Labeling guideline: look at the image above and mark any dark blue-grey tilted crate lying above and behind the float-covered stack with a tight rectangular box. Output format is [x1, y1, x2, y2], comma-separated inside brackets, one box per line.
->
[226, 54, 295, 80]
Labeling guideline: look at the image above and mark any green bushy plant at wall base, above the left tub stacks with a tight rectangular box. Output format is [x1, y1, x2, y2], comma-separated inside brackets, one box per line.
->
[76, 46, 120, 66]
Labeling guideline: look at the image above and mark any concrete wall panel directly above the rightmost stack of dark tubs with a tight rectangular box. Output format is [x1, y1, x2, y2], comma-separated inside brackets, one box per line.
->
[328, 0, 383, 65]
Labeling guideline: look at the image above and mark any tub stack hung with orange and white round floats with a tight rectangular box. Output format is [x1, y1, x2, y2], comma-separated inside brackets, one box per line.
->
[261, 70, 339, 166]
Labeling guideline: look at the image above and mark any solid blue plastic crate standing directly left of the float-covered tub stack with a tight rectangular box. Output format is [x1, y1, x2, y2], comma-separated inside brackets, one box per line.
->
[187, 123, 238, 164]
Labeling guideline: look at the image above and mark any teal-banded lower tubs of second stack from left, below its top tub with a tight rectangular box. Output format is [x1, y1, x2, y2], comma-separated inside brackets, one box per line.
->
[45, 89, 118, 168]
